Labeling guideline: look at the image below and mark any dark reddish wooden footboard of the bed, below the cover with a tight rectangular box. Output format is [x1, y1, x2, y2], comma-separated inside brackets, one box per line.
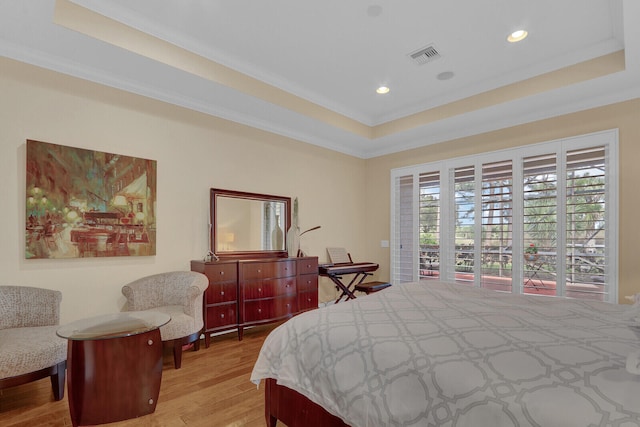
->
[264, 378, 349, 427]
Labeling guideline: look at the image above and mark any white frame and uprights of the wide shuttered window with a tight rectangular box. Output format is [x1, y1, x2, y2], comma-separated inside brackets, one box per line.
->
[390, 129, 619, 303]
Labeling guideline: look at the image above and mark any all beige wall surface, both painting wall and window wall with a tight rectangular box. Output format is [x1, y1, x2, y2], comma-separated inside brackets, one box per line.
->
[0, 59, 640, 322]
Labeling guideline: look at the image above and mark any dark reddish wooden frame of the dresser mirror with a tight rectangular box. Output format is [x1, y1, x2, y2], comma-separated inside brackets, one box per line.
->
[209, 188, 291, 259]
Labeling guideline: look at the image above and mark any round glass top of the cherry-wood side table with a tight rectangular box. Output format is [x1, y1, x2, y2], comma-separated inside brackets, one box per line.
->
[56, 311, 171, 340]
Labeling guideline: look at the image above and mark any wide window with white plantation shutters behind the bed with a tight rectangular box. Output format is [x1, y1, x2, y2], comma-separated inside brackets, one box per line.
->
[391, 130, 618, 302]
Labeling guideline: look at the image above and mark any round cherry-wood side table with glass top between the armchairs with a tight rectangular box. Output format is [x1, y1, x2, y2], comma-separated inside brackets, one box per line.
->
[57, 311, 171, 427]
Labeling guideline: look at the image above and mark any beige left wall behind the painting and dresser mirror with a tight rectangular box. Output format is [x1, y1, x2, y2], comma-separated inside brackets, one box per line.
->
[0, 59, 365, 322]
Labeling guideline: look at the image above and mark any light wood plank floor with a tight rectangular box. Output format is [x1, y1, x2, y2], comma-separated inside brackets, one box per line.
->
[0, 325, 282, 427]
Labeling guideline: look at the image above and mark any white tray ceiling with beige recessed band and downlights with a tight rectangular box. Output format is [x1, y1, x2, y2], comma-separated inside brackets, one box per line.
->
[0, 0, 640, 158]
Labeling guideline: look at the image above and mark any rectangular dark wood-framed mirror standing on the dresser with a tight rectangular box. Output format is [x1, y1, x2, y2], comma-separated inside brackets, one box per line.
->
[210, 188, 291, 258]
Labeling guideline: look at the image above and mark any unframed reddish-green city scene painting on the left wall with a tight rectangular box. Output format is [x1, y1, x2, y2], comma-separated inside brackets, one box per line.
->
[25, 140, 157, 259]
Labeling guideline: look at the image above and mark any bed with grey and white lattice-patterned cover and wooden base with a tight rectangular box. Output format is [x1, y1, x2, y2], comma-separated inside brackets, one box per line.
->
[251, 281, 640, 427]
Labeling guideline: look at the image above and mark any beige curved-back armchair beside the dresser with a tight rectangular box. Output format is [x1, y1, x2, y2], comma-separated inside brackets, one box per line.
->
[122, 271, 209, 369]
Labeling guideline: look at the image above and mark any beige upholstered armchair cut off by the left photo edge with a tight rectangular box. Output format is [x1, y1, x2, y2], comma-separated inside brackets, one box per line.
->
[0, 286, 67, 400]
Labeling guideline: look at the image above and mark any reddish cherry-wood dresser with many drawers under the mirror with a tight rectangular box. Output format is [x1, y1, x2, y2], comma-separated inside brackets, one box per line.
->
[191, 257, 318, 347]
